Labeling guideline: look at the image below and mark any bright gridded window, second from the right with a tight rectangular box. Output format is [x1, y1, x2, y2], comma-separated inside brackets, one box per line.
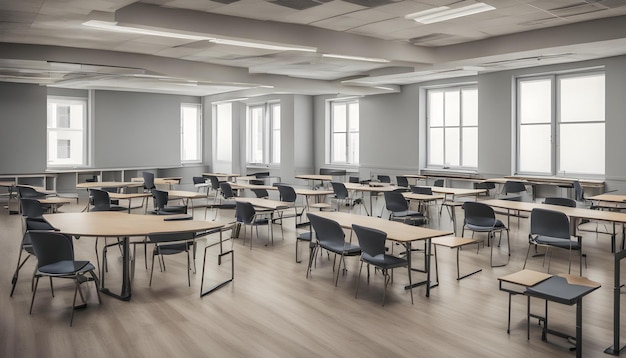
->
[426, 86, 478, 169]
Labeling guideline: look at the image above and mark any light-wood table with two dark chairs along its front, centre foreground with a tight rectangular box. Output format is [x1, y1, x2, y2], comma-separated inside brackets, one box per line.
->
[315, 211, 452, 297]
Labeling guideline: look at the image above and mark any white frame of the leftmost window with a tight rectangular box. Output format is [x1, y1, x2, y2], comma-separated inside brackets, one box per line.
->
[46, 95, 92, 169]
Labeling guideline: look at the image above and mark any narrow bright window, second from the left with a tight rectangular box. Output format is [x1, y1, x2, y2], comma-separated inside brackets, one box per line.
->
[180, 103, 202, 163]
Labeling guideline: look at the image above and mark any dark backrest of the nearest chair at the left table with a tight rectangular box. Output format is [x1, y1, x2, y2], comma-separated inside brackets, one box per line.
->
[30, 231, 74, 268]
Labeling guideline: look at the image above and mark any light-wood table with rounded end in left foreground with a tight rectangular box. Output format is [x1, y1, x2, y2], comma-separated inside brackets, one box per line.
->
[44, 211, 224, 301]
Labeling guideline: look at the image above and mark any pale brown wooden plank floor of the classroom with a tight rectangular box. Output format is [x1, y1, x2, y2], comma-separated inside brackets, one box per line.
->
[0, 194, 626, 358]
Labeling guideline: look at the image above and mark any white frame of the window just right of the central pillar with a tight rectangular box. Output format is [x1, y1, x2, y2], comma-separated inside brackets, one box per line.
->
[327, 97, 361, 166]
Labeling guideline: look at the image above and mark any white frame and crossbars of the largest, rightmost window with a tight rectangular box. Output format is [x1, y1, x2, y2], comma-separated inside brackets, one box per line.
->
[514, 68, 606, 178]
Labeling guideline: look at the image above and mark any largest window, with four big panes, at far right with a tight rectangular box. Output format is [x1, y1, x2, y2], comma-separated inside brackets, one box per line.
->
[517, 72, 605, 176]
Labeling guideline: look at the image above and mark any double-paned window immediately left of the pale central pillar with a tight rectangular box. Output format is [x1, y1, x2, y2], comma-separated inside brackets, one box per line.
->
[247, 102, 280, 164]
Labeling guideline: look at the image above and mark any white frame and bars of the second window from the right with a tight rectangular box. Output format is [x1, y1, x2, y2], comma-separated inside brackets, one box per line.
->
[424, 82, 480, 171]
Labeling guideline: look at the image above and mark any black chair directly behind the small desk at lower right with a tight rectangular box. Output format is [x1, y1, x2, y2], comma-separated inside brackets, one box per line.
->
[524, 208, 583, 276]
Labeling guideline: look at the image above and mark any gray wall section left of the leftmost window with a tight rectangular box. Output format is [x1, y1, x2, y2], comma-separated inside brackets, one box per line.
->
[0, 82, 47, 174]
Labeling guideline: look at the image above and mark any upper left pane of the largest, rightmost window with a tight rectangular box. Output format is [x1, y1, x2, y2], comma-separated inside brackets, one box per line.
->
[520, 79, 552, 124]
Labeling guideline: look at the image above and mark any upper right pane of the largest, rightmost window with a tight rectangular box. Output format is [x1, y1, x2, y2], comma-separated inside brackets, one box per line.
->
[559, 75, 604, 122]
